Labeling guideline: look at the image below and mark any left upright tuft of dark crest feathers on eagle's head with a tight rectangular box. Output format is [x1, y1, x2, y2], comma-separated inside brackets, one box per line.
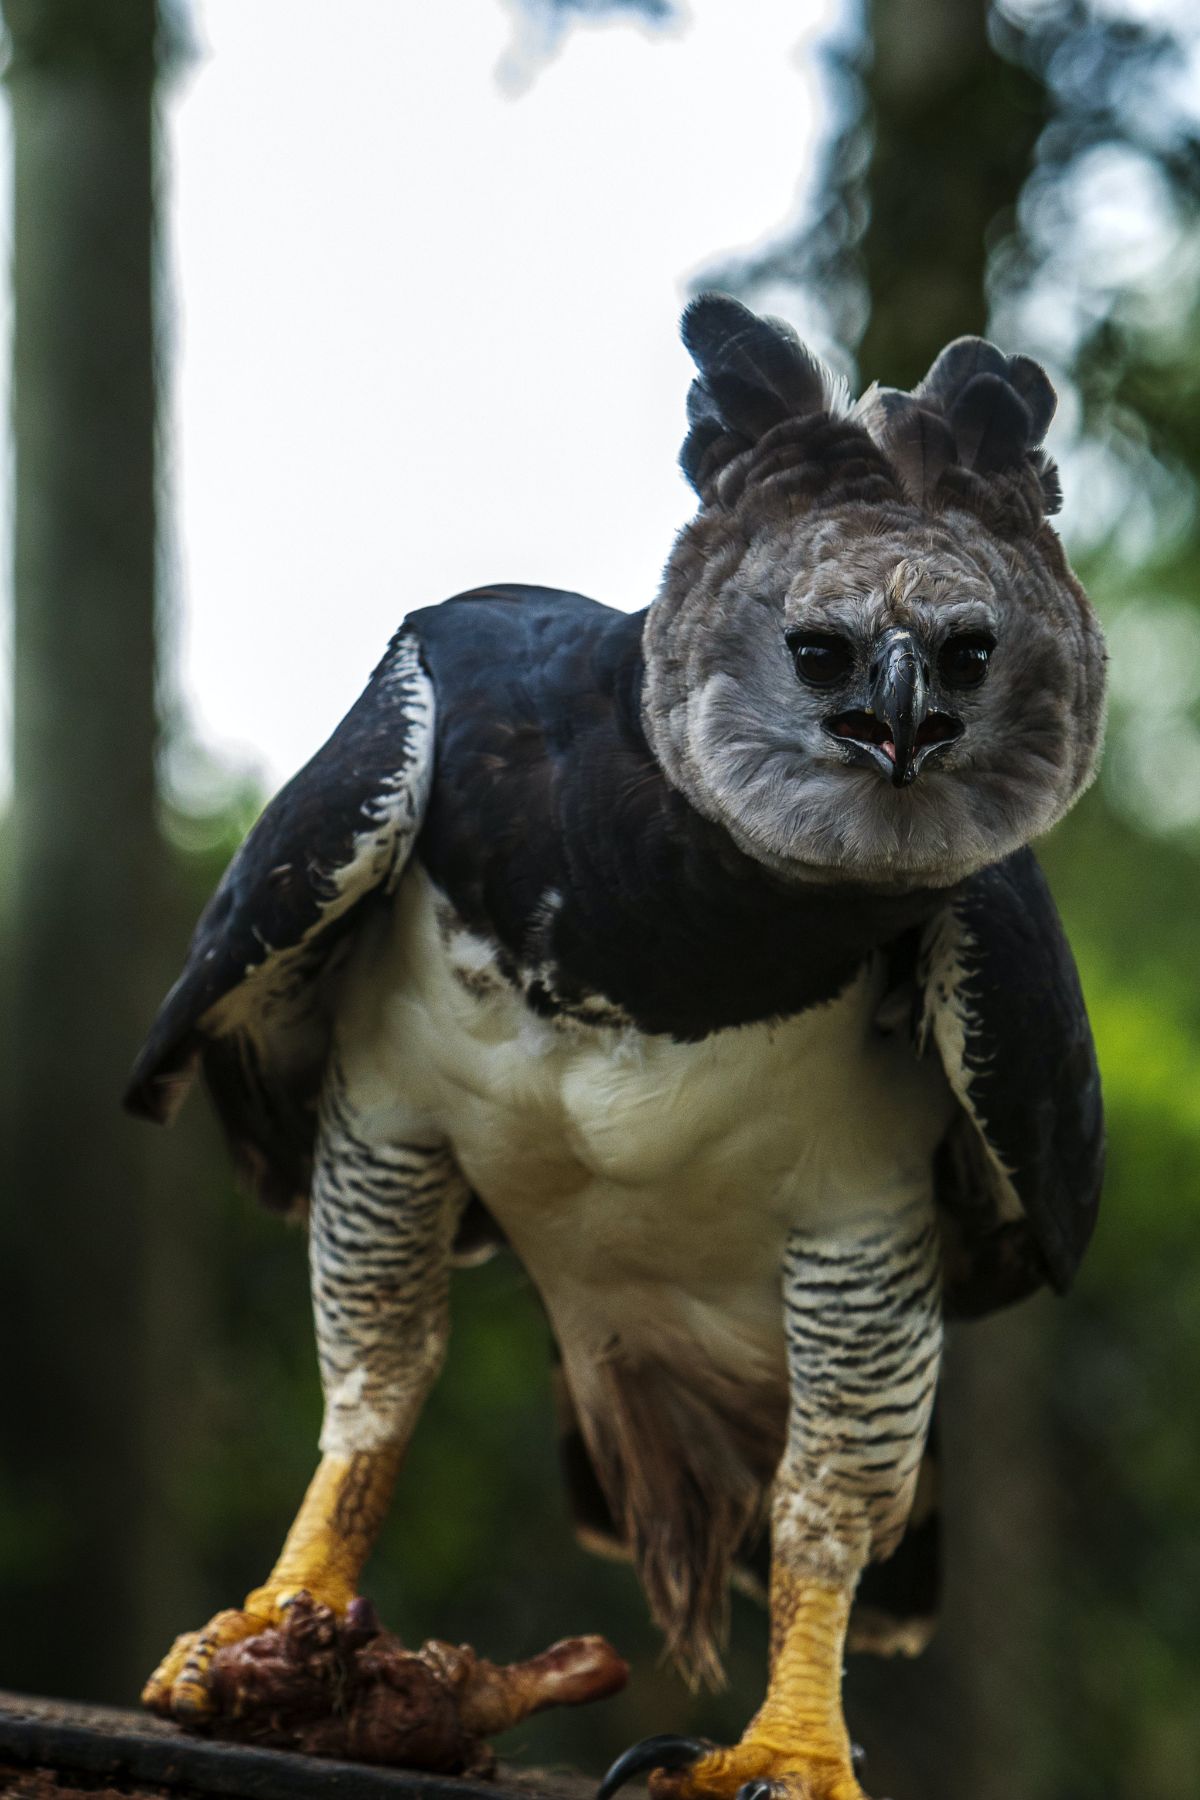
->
[680, 293, 833, 493]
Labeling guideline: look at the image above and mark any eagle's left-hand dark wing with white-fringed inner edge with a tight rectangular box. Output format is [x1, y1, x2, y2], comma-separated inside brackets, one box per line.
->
[126, 630, 434, 1206]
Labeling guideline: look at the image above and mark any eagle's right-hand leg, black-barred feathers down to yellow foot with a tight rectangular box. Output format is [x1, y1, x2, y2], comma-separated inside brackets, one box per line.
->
[601, 1208, 941, 1800]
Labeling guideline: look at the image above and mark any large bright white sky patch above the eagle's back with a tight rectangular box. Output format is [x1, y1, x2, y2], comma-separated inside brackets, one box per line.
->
[159, 0, 844, 785]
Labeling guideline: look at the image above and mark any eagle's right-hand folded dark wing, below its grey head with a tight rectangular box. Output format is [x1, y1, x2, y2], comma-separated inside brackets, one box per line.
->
[918, 850, 1105, 1314]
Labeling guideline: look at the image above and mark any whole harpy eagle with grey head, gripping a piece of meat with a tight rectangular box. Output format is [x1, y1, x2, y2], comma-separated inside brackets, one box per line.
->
[128, 295, 1105, 1800]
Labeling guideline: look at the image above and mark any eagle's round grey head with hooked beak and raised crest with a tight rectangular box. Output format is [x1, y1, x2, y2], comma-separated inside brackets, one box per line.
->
[644, 295, 1105, 887]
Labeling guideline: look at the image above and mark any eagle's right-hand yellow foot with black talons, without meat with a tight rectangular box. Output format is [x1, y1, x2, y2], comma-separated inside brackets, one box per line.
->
[597, 1733, 867, 1800]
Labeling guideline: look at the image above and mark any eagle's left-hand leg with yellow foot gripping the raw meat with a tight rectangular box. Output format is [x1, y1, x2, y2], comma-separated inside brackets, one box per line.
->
[142, 1066, 466, 1721]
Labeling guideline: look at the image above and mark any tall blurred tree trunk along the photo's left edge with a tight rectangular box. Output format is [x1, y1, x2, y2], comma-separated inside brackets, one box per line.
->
[0, 0, 162, 1697]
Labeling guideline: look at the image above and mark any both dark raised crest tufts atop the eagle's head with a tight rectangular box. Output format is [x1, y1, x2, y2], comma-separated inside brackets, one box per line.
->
[680, 293, 1061, 517]
